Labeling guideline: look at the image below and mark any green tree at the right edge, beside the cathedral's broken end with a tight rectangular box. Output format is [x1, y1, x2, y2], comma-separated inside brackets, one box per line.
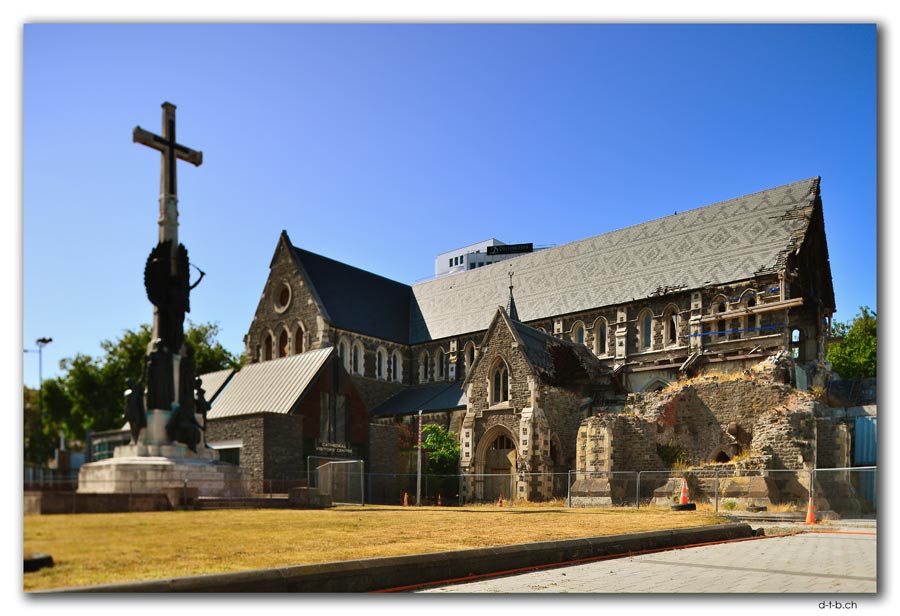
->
[827, 306, 878, 379]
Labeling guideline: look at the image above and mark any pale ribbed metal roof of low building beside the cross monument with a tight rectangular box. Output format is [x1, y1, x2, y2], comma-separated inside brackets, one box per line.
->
[207, 347, 334, 419]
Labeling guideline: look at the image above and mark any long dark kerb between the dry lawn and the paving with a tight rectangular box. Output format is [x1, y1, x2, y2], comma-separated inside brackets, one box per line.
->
[47, 523, 753, 594]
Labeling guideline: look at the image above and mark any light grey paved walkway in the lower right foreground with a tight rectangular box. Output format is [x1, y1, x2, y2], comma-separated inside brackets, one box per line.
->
[422, 524, 876, 593]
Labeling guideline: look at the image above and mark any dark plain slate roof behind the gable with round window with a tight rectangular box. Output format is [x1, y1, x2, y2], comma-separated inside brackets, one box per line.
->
[293, 246, 412, 344]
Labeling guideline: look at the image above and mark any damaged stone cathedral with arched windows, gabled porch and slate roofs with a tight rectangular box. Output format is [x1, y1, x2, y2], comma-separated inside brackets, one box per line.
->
[209, 178, 835, 498]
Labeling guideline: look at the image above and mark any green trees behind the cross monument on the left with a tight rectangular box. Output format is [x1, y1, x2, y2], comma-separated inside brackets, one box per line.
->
[25, 321, 243, 462]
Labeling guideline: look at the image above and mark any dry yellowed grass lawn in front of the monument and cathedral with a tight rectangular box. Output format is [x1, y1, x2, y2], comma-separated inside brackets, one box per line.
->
[24, 505, 726, 591]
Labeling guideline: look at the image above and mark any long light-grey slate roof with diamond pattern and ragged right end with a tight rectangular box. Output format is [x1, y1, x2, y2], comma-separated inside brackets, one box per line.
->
[409, 177, 819, 344]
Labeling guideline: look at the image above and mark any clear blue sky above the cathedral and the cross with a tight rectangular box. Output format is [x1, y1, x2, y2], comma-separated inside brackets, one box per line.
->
[22, 24, 878, 386]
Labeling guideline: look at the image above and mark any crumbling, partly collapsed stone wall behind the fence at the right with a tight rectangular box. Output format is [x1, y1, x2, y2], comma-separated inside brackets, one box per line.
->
[577, 362, 824, 471]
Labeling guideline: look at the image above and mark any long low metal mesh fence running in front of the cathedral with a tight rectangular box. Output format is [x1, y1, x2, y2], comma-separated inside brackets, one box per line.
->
[25, 466, 878, 518]
